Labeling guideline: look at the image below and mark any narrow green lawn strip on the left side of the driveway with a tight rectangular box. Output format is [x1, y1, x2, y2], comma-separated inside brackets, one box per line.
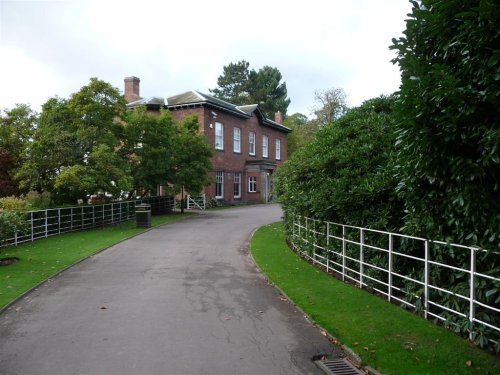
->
[0, 213, 191, 308]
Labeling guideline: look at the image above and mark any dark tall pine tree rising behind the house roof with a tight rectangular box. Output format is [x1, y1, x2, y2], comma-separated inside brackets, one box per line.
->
[209, 60, 290, 118]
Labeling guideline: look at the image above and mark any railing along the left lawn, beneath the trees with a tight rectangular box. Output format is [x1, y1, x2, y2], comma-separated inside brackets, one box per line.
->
[0, 197, 175, 248]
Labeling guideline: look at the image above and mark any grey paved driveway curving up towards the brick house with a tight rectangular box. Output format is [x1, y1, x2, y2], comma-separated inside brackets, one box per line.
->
[0, 205, 333, 375]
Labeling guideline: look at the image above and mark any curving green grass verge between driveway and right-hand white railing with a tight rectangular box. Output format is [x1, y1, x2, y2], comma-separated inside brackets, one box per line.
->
[251, 223, 500, 374]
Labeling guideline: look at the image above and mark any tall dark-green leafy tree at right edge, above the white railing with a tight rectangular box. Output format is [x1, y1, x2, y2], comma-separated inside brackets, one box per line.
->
[392, 0, 500, 250]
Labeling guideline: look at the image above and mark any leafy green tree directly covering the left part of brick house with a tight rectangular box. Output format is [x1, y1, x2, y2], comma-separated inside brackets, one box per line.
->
[120, 107, 212, 206]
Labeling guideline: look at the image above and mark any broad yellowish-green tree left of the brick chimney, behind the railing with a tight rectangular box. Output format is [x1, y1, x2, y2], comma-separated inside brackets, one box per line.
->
[17, 78, 131, 203]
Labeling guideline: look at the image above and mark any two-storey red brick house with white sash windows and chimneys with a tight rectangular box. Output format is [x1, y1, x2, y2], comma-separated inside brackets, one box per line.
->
[124, 77, 291, 202]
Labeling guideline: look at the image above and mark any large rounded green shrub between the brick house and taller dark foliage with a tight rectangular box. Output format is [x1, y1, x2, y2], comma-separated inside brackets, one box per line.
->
[276, 96, 402, 230]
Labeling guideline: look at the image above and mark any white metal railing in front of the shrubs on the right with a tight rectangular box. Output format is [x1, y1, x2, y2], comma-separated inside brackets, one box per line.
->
[291, 215, 500, 342]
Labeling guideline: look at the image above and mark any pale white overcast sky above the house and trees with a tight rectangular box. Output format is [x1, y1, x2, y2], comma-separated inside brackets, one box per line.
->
[0, 0, 411, 115]
